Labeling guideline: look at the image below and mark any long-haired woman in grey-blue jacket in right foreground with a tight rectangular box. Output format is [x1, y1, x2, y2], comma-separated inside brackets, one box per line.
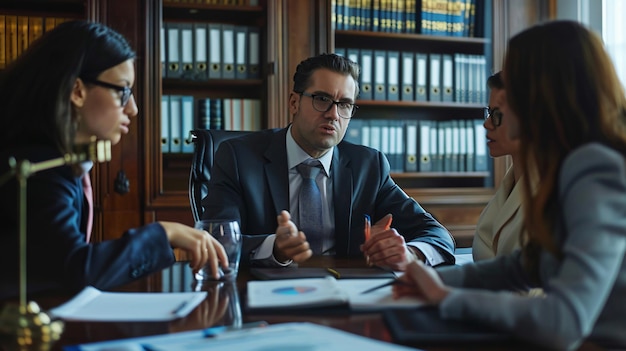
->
[394, 21, 626, 349]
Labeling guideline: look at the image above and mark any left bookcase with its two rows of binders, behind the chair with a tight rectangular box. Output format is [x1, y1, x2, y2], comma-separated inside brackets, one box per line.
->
[144, 0, 286, 225]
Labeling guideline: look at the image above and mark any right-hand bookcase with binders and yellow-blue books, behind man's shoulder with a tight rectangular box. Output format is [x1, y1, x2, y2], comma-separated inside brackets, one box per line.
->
[326, 0, 494, 246]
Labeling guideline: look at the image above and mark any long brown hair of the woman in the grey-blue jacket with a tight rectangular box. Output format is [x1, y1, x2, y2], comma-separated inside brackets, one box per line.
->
[503, 21, 626, 278]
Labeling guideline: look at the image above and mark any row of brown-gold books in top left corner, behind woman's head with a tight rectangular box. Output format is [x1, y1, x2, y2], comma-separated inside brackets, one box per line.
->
[0, 15, 69, 69]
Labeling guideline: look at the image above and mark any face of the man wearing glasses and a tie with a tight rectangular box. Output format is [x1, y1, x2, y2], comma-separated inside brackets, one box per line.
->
[289, 68, 356, 158]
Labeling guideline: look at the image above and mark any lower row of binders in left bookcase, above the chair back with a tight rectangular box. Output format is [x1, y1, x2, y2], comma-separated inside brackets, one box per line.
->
[161, 95, 262, 153]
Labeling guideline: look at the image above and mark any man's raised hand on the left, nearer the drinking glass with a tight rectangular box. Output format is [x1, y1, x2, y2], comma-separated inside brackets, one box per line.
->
[274, 210, 313, 263]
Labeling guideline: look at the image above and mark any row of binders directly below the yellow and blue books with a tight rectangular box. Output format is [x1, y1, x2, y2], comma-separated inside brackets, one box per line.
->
[335, 48, 488, 104]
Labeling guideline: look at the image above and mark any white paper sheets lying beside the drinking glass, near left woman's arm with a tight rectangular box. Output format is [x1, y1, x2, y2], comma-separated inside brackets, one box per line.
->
[48, 287, 207, 322]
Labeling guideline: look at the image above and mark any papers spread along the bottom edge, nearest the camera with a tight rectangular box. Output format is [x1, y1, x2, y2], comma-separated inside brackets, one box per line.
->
[64, 323, 415, 351]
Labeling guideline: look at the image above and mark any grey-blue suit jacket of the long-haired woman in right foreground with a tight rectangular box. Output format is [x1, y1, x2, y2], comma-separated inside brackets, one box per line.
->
[438, 143, 626, 349]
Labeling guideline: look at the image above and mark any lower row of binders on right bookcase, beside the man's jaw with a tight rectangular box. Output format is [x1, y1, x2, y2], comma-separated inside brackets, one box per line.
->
[344, 119, 488, 173]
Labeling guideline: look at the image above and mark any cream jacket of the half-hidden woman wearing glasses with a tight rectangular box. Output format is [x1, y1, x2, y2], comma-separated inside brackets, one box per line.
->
[472, 167, 524, 261]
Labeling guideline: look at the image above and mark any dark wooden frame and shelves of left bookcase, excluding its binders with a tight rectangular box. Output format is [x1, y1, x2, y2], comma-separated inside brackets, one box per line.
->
[144, 0, 287, 230]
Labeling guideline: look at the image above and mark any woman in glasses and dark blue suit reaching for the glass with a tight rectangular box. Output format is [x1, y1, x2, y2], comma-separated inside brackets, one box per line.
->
[0, 21, 227, 296]
